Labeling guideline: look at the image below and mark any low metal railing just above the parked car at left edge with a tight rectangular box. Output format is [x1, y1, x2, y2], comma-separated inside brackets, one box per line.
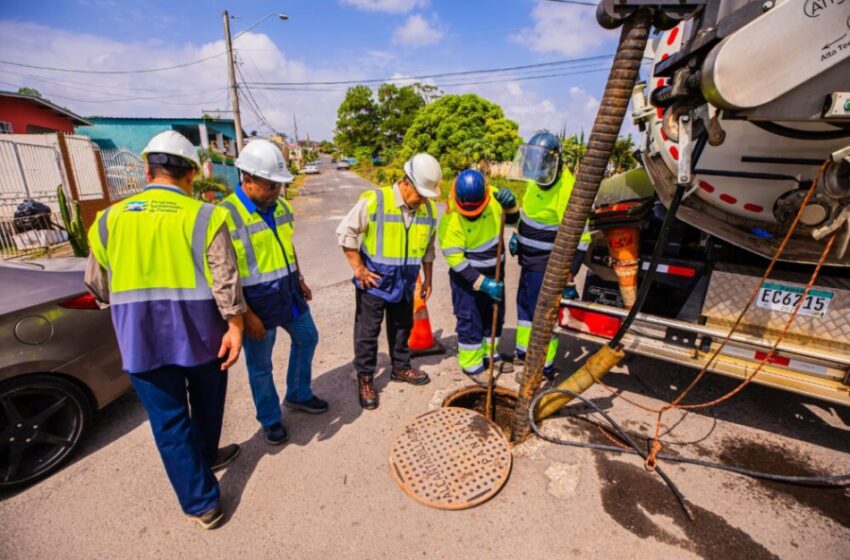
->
[0, 214, 68, 259]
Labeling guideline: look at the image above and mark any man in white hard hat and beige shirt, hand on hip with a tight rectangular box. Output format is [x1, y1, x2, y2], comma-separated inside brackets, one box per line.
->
[336, 154, 443, 409]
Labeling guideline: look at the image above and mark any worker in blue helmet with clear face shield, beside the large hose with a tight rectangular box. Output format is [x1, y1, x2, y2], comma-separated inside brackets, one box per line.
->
[509, 130, 590, 380]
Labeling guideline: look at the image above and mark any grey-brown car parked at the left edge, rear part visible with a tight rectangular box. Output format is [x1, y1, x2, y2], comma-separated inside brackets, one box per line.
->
[0, 258, 130, 490]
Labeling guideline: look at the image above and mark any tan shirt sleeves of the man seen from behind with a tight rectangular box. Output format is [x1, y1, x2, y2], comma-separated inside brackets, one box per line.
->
[85, 225, 248, 321]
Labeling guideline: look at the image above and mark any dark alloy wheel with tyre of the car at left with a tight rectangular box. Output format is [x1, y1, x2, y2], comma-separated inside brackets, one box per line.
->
[0, 375, 91, 490]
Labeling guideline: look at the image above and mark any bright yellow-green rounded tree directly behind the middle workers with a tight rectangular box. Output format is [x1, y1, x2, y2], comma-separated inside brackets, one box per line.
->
[399, 93, 521, 173]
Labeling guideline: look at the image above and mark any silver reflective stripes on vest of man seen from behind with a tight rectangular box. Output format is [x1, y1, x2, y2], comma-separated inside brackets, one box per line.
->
[98, 204, 215, 305]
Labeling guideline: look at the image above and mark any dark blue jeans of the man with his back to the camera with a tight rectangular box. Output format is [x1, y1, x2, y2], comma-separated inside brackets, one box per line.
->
[130, 360, 227, 515]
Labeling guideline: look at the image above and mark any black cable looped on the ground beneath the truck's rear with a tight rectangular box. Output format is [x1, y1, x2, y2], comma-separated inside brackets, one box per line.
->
[528, 388, 850, 486]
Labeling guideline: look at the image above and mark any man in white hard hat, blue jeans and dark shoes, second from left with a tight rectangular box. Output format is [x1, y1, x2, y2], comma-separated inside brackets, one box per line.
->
[221, 139, 328, 445]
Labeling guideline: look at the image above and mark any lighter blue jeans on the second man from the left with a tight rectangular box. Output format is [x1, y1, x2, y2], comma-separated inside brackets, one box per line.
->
[242, 310, 319, 428]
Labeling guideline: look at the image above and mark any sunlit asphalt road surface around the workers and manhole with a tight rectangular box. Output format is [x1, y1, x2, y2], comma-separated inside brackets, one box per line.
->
[0, 165, 850, 560]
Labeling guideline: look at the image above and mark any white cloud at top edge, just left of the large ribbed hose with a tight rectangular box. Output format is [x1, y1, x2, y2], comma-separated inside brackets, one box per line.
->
[510, 0, 616, 56]
